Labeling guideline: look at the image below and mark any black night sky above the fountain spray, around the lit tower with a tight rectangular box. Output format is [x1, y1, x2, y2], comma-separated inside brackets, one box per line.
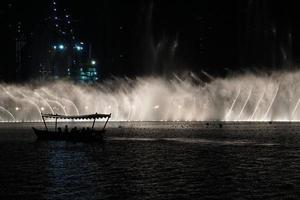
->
[0, 0, 300, 81]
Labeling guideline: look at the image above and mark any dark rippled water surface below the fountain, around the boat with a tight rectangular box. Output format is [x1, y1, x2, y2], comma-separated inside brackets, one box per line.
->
[0, 122, 300, 199]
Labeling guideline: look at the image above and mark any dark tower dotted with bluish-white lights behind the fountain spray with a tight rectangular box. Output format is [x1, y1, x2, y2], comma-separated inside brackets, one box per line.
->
[38, 0, 98, 83]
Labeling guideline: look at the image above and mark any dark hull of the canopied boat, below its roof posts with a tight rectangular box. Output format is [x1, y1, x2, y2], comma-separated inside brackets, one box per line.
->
[32, 128, 105, 142]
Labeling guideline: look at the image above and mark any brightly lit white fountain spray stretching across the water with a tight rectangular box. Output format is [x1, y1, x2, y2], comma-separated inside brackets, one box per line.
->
[0, 72, 300, 122]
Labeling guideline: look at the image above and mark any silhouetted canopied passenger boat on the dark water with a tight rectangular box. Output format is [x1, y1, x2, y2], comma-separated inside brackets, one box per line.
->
[32, 113, 111, 142]
